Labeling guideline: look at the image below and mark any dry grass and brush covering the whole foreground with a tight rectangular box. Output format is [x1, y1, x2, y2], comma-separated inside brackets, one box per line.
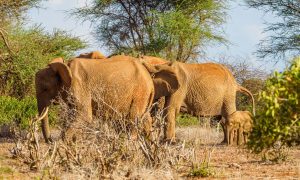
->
[0, 97, 300, 179]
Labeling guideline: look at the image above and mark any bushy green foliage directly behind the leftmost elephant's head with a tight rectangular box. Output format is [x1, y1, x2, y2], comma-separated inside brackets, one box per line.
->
[0, 26, 85, 98]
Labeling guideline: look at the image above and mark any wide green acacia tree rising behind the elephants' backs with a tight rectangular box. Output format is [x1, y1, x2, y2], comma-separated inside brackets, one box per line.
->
[73, 0, 226, 61]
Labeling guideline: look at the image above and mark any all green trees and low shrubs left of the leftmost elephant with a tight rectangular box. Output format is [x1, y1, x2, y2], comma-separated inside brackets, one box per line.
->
[0, 0, 86, 127]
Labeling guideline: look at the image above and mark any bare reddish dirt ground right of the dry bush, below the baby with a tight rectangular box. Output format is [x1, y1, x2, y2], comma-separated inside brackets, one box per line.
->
[177, 127, 300, 179]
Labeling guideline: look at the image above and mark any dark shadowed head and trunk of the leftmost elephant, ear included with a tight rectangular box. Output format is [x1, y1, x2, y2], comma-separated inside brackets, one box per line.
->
[35, 58, 72, 142]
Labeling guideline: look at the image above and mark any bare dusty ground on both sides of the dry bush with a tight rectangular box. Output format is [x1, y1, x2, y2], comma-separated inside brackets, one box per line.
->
[0, 127, 300, 179]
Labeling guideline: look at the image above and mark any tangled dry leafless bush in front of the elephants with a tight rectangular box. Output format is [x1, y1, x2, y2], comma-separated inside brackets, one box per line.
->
[11, 92, 223, 179]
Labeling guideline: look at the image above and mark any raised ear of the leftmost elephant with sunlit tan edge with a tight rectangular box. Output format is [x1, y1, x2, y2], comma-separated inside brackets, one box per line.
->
[49, 58, 72, 87]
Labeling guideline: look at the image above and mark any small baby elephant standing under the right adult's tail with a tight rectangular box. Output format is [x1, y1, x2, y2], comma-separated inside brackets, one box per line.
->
[226, 111, 253, 145]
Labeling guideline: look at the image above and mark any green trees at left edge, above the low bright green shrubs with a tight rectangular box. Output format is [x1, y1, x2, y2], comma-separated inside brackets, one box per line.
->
[0, 0, 85, 98]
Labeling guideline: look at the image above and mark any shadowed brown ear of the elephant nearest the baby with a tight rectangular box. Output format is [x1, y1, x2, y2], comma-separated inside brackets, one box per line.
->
[143, 63, 180, 99]
